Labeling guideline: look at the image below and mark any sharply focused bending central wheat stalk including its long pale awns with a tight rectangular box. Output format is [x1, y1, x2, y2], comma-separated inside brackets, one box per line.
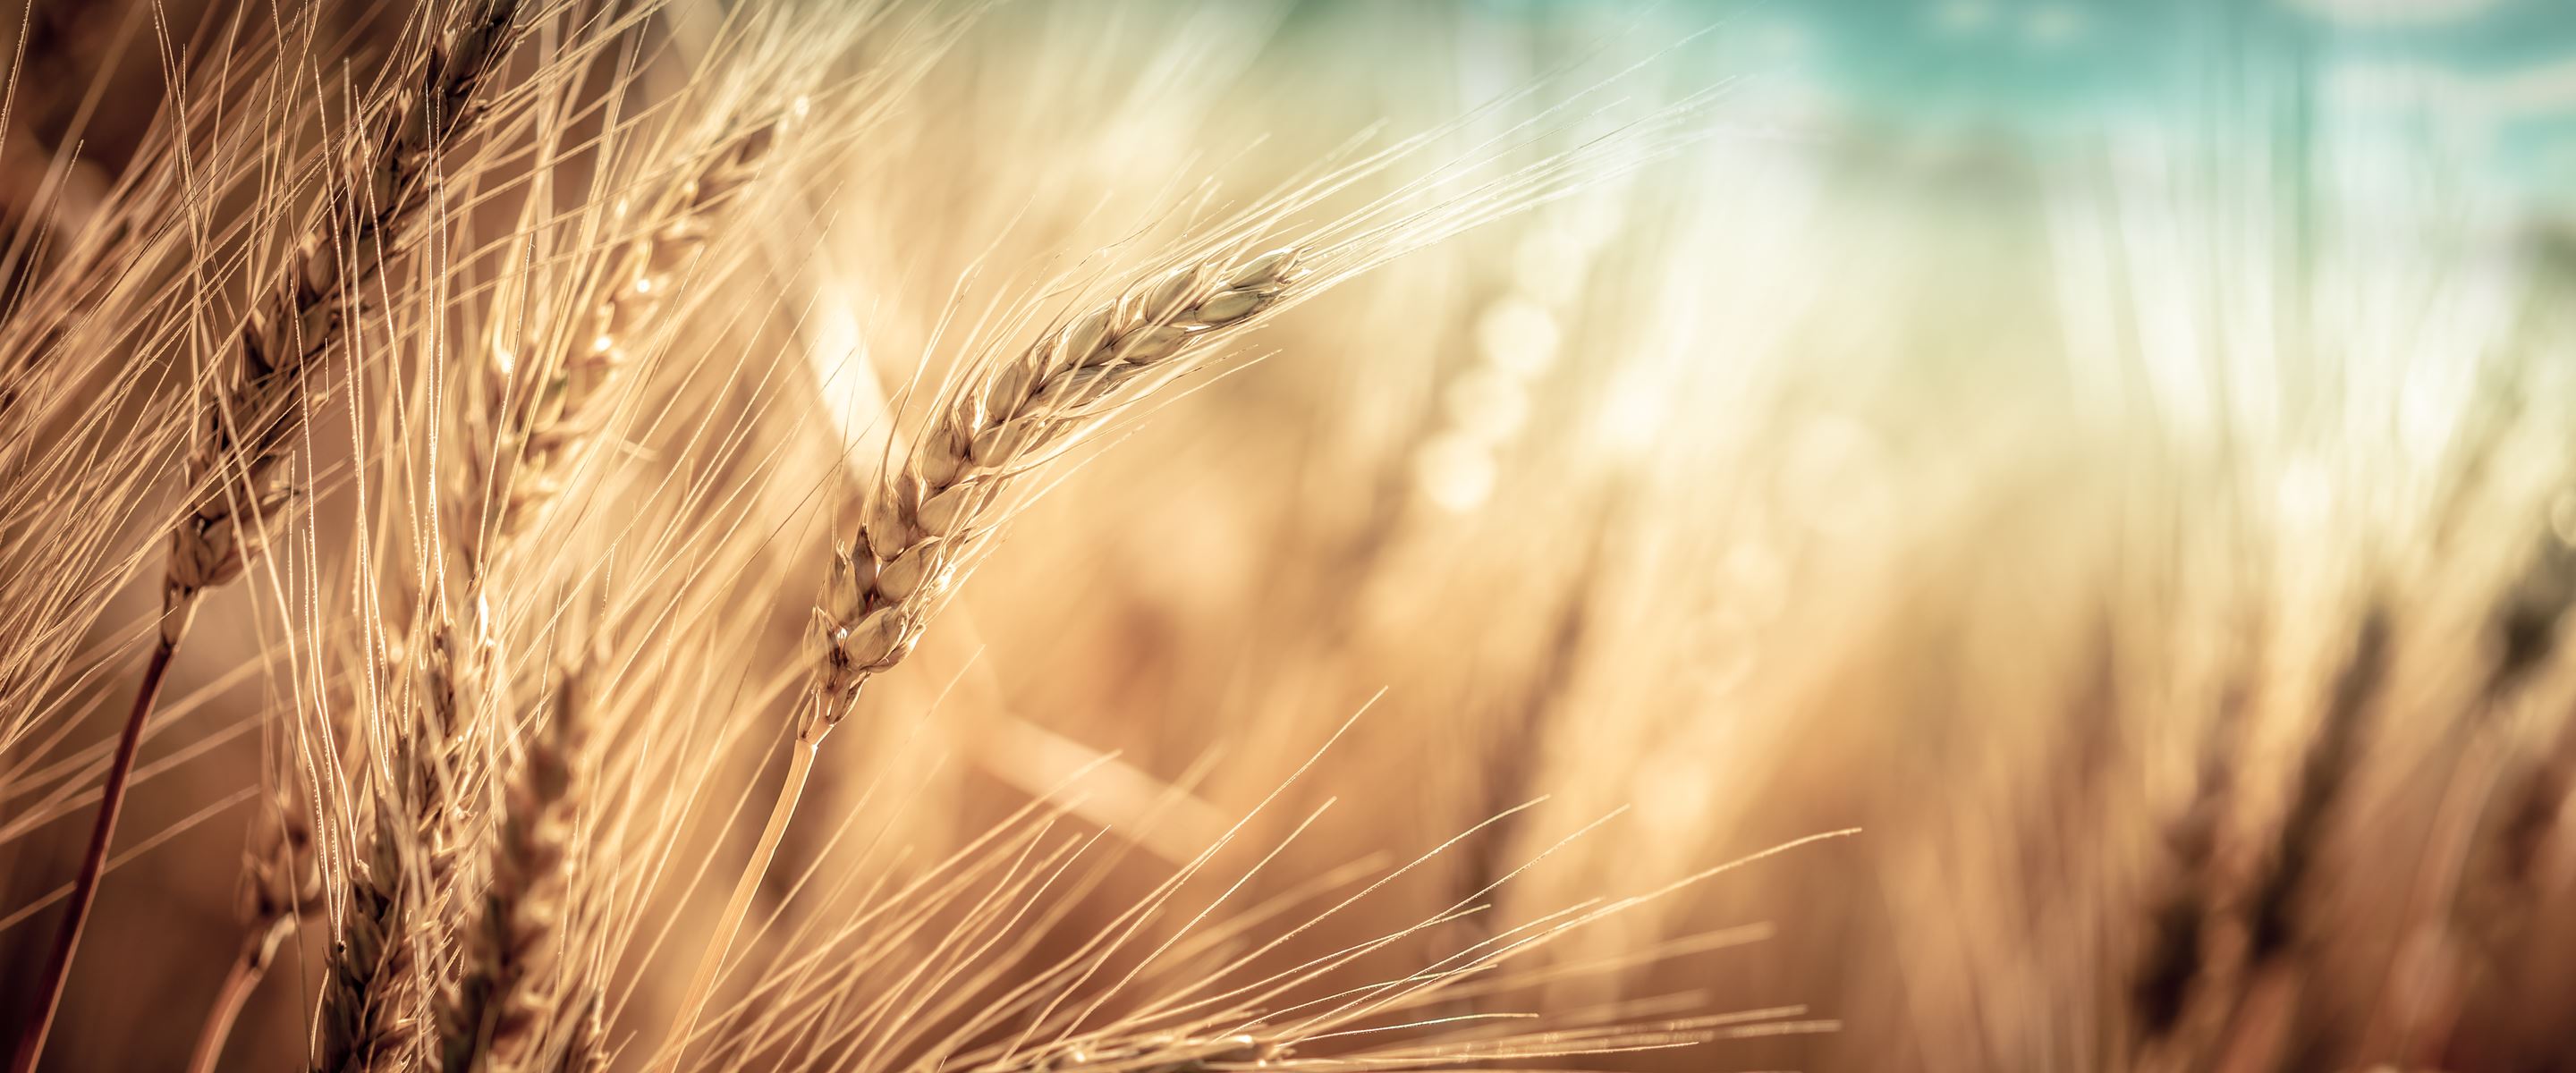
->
[662, 108, 1687, 1068]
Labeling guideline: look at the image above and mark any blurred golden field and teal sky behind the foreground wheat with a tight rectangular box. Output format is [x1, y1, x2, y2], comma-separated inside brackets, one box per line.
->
[14, 0, 2576, 1070]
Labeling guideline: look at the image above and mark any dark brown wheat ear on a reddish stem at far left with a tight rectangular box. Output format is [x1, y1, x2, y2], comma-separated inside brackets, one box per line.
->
[11, 0, 521, 1073]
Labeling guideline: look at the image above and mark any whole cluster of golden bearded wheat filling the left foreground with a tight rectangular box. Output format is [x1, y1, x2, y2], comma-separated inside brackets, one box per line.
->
[0, 0, 1854, 1073]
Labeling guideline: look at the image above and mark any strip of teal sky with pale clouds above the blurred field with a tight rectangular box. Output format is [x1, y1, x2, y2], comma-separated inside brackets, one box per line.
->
[1489, 0, 2576, 200]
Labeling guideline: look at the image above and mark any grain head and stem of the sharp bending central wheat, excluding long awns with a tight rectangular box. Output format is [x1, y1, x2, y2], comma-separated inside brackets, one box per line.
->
[665, 247, 1306, 1068]
